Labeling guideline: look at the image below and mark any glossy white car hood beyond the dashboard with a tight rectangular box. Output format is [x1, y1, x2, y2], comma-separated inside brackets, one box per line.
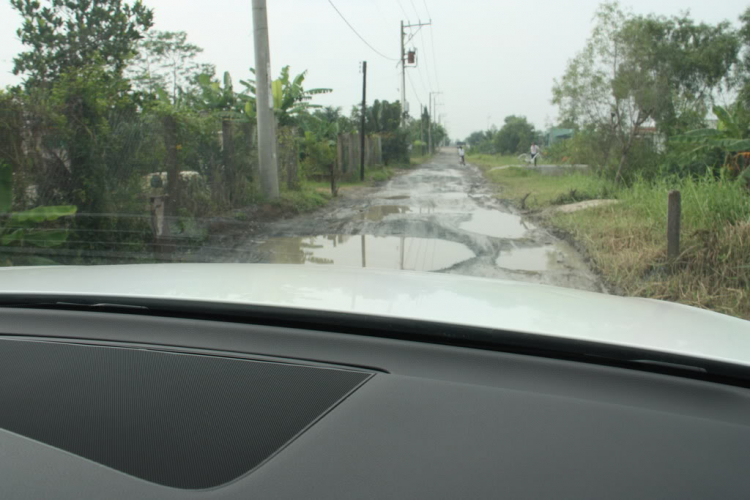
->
[0, 264, 750, 366]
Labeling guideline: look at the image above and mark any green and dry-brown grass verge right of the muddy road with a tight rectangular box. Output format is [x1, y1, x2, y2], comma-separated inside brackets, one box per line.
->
[483, 164, 750, 319]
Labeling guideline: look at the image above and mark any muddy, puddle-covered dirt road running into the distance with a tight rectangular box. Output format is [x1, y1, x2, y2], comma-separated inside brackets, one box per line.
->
[216, 152, 603, 291]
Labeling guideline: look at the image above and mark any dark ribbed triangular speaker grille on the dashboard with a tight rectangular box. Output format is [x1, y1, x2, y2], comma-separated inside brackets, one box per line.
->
[0, 339, 371, 489]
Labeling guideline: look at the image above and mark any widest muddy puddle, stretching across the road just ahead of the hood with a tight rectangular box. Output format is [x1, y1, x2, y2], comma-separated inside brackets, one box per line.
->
[259, 235, 474, 271]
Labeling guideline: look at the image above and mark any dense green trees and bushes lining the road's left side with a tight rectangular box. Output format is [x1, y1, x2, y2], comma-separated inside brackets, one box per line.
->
[0, 0, 447, 263]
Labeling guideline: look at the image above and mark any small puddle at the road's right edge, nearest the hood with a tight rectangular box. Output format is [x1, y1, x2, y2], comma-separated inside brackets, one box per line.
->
[495, 242, 585, 272]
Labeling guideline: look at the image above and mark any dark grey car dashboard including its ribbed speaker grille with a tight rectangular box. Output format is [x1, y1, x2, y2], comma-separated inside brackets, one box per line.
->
[0, 308, 750, 499]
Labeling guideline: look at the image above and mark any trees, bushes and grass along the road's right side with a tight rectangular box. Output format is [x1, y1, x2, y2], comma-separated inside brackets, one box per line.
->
[469, 2, 750, 319]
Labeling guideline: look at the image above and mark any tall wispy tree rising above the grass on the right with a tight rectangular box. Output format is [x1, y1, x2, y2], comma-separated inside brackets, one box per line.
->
[553, 2, 739, 180]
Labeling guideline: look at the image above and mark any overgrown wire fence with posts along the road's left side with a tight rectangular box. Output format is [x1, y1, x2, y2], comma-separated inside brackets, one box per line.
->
[0, 96, 308, 265]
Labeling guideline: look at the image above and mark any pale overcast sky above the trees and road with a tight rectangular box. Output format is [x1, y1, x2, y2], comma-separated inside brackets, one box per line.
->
[0, 0, 748, 138]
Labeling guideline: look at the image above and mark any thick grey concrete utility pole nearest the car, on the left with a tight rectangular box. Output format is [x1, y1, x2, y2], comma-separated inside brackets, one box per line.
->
[253, 0, 279, 199]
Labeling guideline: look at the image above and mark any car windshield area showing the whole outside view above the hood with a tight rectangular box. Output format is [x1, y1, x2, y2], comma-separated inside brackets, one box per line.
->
[0, 0, 750, 319]
